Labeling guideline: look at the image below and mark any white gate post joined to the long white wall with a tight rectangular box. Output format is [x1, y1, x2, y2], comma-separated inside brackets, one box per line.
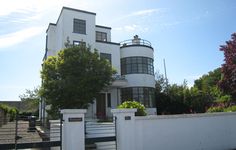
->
[111, 109, 137, 150]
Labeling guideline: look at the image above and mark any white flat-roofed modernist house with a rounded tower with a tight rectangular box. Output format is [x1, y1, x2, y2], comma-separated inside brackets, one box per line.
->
[44, 7, 156, 118]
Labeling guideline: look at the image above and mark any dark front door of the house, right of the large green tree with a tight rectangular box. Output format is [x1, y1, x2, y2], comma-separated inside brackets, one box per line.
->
[96, 93, 106, 119]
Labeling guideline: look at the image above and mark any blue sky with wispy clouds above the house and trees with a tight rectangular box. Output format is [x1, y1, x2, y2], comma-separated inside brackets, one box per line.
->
[0, 0, 236, 101]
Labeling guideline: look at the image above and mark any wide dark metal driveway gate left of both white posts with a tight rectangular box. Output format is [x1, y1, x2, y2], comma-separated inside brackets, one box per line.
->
[0, 116, 62, 150]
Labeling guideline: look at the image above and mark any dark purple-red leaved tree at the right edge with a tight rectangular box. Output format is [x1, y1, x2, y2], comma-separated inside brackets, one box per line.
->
[219, 33, 236, 99]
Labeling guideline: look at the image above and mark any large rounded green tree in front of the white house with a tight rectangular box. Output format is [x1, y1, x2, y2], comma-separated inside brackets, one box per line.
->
[40, 45, 114, 117]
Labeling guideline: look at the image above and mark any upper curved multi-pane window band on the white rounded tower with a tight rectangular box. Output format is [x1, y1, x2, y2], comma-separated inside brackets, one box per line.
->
[121, 57, 154, 75]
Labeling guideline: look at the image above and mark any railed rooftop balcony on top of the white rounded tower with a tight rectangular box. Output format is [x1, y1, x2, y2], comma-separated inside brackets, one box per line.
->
[120, 35, 152, 48]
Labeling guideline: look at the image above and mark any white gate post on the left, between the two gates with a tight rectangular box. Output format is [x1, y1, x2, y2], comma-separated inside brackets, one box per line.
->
[61, 109, 87, 150]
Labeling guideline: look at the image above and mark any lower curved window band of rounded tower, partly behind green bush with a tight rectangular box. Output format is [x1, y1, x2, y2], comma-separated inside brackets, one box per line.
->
[121, 87, 155, 108]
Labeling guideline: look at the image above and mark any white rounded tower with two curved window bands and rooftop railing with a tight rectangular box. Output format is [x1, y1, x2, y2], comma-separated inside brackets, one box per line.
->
[120, 35, 156, 114]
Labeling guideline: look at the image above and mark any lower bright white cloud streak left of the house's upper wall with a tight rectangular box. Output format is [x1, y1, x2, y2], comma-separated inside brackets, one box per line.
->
[0, 27, 45, 49]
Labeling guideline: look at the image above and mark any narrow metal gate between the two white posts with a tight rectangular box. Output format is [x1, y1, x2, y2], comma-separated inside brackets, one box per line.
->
[85, 117, 117, 150]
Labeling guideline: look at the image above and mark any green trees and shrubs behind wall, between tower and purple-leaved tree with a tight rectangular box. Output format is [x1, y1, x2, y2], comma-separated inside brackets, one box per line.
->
[155, 69, 223, 114]
